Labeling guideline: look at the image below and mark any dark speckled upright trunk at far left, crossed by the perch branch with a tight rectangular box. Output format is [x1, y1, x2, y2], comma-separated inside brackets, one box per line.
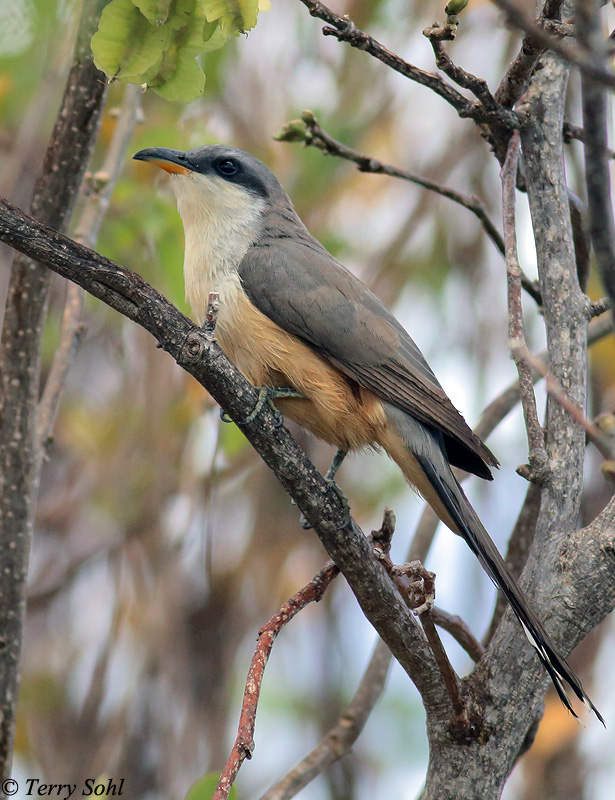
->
[0, 0, 106, 777]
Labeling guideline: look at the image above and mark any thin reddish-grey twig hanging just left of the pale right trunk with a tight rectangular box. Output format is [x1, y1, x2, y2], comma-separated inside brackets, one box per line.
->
[501, 131, 547, 482]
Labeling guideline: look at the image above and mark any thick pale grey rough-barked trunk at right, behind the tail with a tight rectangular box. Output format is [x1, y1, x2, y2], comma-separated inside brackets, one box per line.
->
[422, 45, 615, 800]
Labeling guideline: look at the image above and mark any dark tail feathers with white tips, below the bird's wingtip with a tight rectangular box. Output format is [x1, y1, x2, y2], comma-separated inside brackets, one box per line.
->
[414, 452, 606, 727]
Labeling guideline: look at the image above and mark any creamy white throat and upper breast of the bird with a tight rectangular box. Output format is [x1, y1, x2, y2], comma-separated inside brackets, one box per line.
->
[171, 172, 265, 323]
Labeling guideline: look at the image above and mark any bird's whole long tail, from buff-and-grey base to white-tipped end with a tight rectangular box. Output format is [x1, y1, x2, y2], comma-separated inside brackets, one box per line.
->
[382, 404, 606, 727]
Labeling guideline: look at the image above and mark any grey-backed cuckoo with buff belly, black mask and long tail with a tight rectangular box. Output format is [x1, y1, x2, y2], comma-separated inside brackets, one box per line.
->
[134, 145, 602, 720]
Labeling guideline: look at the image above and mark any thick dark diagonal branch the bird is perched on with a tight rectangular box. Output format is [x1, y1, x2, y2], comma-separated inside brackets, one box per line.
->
[0, 200, 460, 728]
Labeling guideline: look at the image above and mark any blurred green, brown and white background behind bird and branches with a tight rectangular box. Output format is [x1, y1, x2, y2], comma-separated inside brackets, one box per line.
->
[0, 0, 615, 800]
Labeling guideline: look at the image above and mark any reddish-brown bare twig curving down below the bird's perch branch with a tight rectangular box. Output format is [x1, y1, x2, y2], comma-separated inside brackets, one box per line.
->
[212, 561, 339, 800]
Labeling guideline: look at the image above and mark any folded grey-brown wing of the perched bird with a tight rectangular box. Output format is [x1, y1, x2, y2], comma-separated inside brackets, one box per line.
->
[239, 218, 498, 478]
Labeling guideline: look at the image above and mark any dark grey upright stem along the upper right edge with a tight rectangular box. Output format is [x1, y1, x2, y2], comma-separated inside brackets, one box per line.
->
[575, 0, 615, 318]
